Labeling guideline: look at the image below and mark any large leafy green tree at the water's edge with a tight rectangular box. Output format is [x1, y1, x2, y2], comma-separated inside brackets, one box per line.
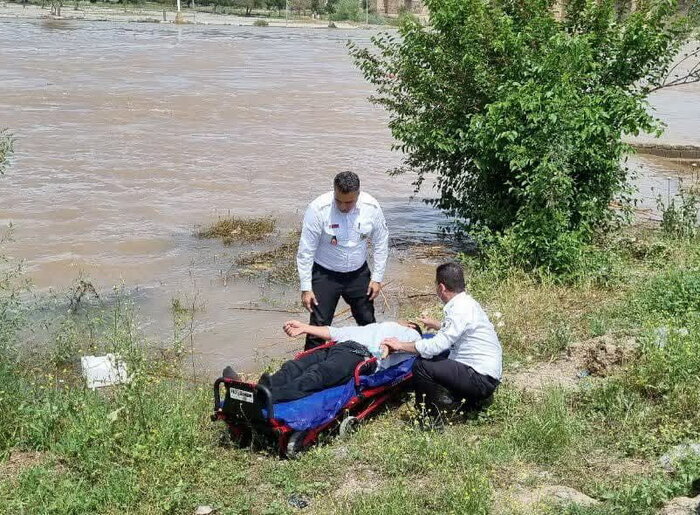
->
[350, 0, 698, 273]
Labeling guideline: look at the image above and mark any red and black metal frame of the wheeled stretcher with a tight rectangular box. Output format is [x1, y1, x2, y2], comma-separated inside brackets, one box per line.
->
[211, 342, 412, 458]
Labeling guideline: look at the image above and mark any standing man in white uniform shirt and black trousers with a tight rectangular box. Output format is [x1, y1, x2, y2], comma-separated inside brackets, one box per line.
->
[297, 172, 389, 350]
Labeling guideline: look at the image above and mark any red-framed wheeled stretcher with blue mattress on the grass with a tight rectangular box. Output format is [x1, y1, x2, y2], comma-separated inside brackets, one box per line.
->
[212, 342, 415, 458]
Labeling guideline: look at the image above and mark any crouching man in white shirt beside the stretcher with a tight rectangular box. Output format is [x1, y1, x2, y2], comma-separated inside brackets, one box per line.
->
[382, 263, 502, 415]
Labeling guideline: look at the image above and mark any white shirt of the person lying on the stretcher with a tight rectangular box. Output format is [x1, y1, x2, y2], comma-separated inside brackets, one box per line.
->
[328, 322, 421, 370]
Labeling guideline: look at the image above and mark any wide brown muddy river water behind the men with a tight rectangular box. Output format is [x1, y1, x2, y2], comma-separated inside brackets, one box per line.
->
[0, 20, 700, 373]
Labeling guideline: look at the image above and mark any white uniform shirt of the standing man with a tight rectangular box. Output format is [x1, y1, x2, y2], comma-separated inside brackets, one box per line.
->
[297, 191, 389, 291]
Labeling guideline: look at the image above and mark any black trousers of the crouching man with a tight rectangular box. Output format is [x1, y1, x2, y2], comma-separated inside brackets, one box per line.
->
[413, 352, 500, 415]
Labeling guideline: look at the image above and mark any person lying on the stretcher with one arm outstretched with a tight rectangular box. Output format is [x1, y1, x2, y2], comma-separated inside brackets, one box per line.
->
[224, 320, 422, 403]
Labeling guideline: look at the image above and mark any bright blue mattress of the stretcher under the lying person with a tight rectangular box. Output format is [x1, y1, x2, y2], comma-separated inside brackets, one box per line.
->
[274, 357, 416, 431]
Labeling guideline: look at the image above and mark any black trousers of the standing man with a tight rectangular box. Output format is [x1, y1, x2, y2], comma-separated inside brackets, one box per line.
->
[304, 263, 376, 350]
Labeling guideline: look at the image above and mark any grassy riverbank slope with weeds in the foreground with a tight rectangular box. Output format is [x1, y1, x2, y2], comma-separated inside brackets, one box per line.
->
[0, 231, 700, 515]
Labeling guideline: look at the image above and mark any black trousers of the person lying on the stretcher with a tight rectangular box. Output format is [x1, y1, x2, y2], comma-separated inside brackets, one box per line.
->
[260, 341, 376, 402]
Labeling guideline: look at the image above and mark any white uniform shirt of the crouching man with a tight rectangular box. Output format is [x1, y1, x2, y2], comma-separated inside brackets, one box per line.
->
[416, 292, 502, 380]
